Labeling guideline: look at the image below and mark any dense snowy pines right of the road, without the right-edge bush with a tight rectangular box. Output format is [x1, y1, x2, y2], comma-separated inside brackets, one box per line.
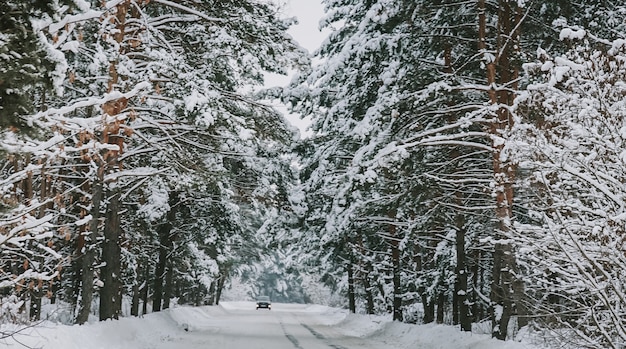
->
[285, 1, 623, 343]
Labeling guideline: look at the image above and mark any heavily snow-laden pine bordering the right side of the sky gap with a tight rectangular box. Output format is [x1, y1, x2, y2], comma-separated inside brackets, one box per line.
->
[286, 1, 422, 319]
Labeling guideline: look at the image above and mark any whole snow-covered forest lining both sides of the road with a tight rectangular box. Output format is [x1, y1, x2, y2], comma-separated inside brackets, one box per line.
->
[0, 0, 626, 348]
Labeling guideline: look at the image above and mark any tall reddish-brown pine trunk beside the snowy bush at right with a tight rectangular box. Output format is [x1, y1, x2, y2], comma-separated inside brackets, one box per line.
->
[478, 0, 523, 340]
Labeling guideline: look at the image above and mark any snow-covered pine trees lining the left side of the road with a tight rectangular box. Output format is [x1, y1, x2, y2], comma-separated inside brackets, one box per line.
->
[0, 0, 306, 324]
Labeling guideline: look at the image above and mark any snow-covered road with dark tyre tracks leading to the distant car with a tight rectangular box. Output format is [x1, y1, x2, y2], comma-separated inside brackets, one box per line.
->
[159, 303, 393, 349]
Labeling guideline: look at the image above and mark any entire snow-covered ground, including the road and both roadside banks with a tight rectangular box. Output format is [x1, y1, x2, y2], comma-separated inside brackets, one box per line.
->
[0, 302, 543, 349]
